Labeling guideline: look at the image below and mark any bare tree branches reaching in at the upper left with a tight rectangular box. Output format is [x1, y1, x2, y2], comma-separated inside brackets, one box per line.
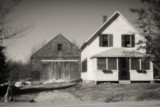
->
[0, 0, 33, 46]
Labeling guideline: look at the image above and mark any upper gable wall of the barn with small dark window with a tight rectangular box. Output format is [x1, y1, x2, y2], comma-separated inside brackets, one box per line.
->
[31, 34, 80, 59]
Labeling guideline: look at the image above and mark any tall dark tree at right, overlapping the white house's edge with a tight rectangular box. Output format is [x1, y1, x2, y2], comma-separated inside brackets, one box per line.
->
[130, 0, 160, 78]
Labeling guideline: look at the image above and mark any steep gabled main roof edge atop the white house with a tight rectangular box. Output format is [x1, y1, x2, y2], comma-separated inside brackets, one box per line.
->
[81, 11, 146, 50]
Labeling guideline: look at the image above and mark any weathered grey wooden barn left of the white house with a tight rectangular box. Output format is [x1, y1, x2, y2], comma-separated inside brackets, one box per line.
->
[31, 34, 81, 82]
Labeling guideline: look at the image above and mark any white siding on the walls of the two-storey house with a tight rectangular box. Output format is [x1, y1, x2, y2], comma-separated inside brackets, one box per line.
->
[81, 11, 153, 81]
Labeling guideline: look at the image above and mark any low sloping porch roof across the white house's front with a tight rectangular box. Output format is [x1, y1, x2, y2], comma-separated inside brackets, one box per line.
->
[92, 48, 150, 58]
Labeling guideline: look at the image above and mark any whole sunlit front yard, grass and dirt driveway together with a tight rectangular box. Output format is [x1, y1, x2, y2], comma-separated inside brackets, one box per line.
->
[0, 84, 160, 107]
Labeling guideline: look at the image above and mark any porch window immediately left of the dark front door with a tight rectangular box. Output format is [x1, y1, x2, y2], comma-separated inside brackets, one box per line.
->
[108, 58, 117, 70]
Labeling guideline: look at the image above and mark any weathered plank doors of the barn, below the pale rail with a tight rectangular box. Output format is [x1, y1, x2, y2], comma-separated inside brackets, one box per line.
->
[45, 62, 80, 81]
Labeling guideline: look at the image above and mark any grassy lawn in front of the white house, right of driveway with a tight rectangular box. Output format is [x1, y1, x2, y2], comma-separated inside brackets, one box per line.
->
[66, 83, 160, 102]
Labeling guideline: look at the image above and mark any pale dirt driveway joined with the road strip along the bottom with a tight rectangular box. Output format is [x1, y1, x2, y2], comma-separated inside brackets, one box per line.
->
[0, 90, 160, 107]
